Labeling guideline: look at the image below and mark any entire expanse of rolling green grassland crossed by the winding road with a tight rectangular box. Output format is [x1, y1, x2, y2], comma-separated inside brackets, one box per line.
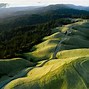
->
[0, 20, 89, 89]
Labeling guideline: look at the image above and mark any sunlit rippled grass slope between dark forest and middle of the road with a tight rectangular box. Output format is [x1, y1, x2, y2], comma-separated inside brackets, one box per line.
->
[24, 38, 59, 61]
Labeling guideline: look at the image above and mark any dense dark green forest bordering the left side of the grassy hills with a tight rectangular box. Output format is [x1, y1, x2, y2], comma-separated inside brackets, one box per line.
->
[0, 19, 71, 58]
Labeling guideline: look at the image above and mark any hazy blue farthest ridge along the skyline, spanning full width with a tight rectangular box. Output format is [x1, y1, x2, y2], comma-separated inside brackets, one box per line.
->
[0, 4, 89, 18]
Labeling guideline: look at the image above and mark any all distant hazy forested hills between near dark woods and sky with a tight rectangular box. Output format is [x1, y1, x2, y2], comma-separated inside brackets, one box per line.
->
[0, 4, 89, 30]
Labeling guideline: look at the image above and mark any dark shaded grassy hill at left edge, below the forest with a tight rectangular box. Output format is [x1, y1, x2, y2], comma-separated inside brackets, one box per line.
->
[0, 58, 33, 76]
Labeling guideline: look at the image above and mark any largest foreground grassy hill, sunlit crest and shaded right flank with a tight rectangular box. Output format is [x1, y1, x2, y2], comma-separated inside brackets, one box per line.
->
[3, 49, 89, 89]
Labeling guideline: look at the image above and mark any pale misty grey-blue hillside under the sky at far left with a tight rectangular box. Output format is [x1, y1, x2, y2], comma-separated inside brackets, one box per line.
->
[0, 6, 38, 18]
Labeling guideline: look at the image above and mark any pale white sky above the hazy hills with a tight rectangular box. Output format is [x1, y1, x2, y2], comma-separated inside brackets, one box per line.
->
[0, 0, 89, 7]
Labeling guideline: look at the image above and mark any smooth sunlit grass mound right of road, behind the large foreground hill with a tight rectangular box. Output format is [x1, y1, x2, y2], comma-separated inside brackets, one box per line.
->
[56, 49, 89, 59]
